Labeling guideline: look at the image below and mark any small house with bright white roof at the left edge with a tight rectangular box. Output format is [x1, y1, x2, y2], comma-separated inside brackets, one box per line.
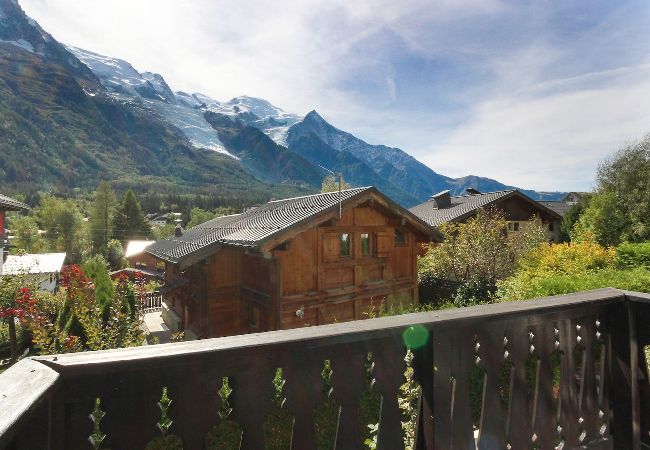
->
[3, 253, 65, 292]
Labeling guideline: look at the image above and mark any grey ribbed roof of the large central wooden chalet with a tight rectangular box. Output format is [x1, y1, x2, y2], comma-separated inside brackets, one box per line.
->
[145, 187, 439, 263]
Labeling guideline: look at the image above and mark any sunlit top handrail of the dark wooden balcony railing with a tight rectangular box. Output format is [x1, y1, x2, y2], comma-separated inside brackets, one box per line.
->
[0, 288, 650, 448]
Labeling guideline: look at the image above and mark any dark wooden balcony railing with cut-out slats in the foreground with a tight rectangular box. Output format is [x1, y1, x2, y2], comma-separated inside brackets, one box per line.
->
[0, 289, 650, 450]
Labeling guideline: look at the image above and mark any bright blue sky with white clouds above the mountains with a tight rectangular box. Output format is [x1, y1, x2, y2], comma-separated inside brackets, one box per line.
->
[21, 0, 650, 191]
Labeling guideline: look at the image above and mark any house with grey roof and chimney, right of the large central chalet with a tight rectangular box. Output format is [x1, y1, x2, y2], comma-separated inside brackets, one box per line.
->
[409, 189, 562, 241]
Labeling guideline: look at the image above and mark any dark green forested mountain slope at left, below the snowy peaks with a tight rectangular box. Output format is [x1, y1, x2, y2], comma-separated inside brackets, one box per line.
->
[0, 0, 306, 201]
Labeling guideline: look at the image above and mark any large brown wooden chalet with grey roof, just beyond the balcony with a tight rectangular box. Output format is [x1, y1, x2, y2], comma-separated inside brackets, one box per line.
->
[145, 187, 441, 337]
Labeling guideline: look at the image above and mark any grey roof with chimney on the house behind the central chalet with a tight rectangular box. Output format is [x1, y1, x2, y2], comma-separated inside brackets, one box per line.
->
[409, 189, 560, 227]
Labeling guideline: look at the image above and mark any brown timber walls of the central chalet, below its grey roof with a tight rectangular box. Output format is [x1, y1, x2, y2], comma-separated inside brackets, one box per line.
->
[158, 193, 436, 337]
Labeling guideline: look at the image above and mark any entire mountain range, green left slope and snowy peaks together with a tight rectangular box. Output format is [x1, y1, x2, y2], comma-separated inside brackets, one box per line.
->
[0, 0, 553, 206]
